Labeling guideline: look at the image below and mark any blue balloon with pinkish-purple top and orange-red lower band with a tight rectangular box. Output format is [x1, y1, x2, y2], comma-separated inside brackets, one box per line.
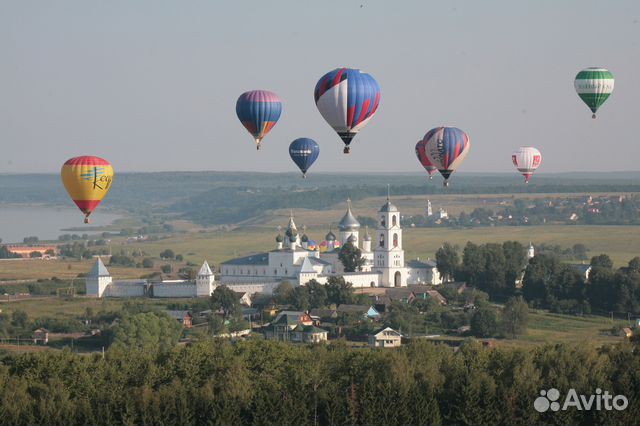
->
[236, 90, 282, 149]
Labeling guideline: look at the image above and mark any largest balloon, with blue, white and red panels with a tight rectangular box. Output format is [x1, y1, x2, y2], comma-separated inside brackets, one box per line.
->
[314, 68, 380, 154]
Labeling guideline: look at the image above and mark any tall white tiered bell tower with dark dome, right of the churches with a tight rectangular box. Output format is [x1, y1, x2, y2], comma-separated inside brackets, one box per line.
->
[373, 196, 407, 287]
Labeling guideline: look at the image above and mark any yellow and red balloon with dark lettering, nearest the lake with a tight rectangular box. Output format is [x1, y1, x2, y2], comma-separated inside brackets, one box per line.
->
[60, 155, 113, 223]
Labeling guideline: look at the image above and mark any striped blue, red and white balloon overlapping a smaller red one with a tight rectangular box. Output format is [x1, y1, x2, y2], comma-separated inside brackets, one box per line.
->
[422, 127, 470, 186]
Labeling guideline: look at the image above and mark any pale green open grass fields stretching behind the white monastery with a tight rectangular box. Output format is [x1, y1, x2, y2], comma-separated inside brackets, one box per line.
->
[0, 223, 640, 285]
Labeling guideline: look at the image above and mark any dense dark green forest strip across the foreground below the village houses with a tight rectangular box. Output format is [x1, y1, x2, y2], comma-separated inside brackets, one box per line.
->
[0, 340, 640, 425]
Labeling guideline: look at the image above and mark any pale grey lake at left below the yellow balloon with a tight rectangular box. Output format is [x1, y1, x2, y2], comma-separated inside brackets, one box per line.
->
[0, 206, 121, 243]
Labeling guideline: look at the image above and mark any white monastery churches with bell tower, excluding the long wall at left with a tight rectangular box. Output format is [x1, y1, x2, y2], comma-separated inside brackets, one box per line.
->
[220, 197, 442, 290]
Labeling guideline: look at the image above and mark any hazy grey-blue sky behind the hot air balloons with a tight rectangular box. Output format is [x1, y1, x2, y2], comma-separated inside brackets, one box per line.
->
[0, 0, 640, 172]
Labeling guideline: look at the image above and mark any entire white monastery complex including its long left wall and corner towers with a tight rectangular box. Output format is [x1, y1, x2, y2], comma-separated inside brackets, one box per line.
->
[86, 197, 442, 297]
